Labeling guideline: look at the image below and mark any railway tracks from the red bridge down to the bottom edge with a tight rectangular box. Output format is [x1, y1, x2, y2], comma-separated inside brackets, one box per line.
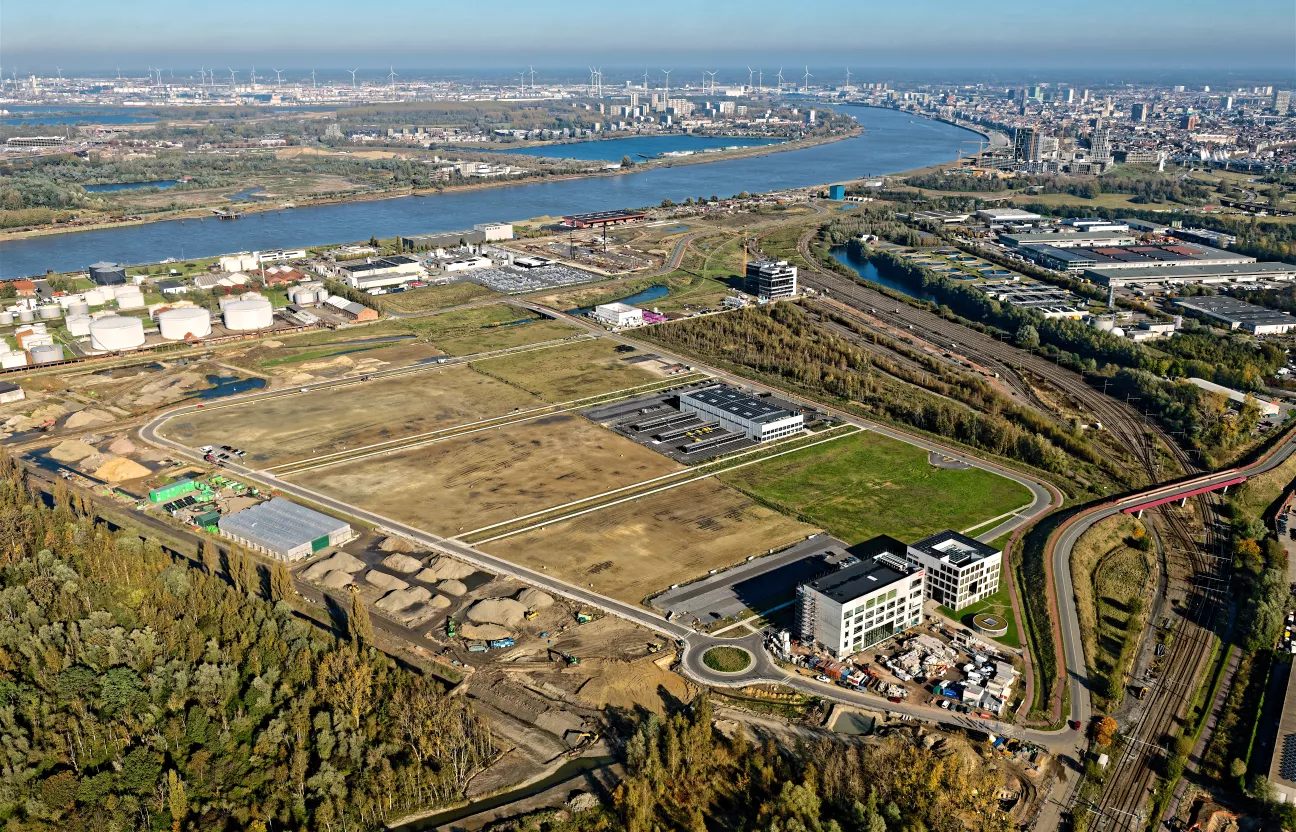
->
[1090, 495, 1229, 832]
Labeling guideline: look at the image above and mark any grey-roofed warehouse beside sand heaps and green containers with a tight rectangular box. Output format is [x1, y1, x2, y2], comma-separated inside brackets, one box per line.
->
[216, 496, 355, 561]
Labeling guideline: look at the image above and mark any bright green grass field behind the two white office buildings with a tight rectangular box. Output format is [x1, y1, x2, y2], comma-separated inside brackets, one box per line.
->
[721, 432, 1030, 544]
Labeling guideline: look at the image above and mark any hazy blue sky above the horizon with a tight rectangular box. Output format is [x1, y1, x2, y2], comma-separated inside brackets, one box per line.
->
[0, 0, 1296, 83]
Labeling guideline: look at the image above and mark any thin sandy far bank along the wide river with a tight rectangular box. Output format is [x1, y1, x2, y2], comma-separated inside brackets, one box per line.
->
[0, 127, 863, 242]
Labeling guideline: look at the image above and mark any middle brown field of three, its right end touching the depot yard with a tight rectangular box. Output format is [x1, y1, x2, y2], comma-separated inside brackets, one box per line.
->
[293, 413, 682, 535]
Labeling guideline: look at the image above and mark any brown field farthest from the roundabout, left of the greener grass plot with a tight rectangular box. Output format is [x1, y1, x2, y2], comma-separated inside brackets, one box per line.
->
[162, 365, 539, 468]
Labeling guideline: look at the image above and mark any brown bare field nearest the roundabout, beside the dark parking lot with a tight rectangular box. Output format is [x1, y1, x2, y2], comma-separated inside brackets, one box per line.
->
[482, 478, 816, 604]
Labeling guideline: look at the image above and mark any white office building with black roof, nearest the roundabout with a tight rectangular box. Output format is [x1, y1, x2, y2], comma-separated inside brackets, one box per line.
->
[796, 537, 925, 658]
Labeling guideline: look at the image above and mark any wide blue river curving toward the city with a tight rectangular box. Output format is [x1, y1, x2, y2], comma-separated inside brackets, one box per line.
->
[0, 106, 975, 277]
